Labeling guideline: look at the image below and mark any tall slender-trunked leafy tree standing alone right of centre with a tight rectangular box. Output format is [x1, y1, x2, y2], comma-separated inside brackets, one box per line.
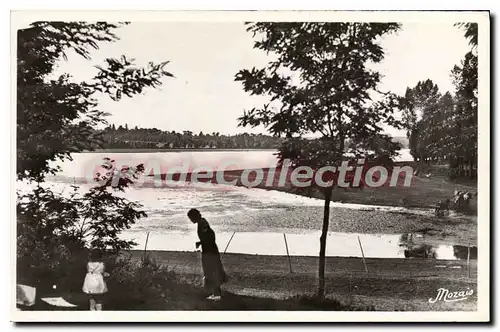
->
[235, 22, 401, 296]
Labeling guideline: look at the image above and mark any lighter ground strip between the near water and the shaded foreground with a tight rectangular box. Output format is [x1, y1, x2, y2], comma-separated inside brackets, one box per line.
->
[132, 251, 477, 311]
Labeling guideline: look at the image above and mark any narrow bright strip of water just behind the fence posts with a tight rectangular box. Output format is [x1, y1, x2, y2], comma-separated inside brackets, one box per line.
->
[126, 227, 477, 260]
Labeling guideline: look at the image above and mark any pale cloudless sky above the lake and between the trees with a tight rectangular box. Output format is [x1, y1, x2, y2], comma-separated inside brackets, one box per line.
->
[54, 22, 469, 136]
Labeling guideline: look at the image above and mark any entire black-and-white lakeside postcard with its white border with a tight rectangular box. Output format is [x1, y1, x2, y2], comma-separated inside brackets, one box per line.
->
[10, 11, 490, 322]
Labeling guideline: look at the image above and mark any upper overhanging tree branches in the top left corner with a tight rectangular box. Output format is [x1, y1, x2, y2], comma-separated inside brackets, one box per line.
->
[17, 22, 172, 181]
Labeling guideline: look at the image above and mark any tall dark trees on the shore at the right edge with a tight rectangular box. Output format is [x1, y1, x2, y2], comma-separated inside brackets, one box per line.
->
[404, 23, 478, 178]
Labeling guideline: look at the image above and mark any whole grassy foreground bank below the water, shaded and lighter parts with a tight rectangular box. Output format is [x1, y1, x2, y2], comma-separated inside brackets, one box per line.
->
[20, 251, 477, 311]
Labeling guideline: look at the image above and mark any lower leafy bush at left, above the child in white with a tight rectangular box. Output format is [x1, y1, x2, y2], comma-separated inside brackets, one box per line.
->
[17, 162, 146, 280]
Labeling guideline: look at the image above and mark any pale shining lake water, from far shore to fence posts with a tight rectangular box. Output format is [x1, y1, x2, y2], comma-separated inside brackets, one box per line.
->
[18, 150, 476, 259]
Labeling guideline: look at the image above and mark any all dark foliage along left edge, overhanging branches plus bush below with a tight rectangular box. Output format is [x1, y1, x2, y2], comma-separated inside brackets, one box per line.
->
[17, 22, 172, 280]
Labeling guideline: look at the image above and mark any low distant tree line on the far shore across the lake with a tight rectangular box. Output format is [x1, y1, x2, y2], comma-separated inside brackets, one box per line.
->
[100, 124, 281, 149]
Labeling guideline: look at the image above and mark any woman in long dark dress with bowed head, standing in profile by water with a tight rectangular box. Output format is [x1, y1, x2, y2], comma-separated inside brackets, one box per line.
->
[188, 209, 227, 301]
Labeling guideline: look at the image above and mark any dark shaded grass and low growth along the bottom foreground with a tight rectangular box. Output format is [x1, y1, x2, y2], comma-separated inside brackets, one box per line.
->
[17, 254, 374, 311]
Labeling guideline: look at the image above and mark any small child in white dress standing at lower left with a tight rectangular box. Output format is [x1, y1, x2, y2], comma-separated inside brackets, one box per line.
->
[82, 251, 109, 311]
